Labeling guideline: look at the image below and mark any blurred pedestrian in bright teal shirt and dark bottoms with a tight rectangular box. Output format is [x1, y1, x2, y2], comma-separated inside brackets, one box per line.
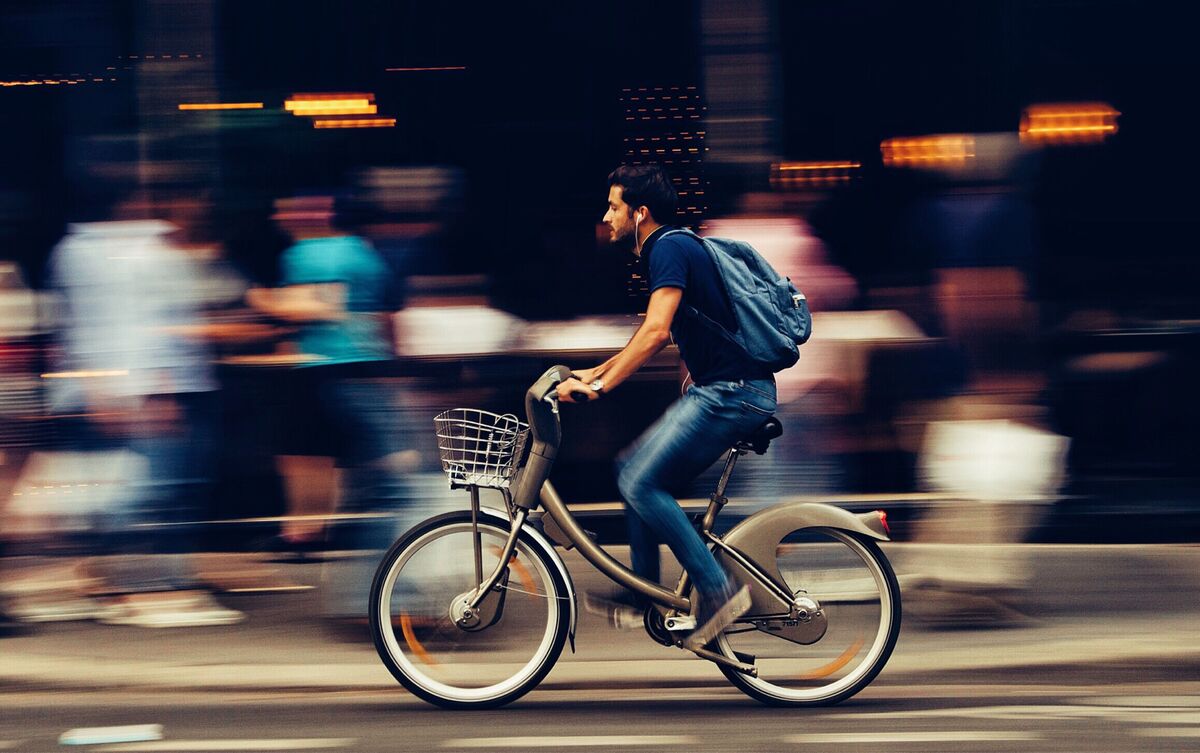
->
[247, 197, 413, 622]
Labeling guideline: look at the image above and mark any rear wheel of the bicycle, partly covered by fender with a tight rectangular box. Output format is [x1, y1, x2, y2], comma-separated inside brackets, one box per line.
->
[716, 528, 900, 706]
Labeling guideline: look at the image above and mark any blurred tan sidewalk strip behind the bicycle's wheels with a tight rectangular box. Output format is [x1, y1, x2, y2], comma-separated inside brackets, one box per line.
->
[0, 544, 1200, 692]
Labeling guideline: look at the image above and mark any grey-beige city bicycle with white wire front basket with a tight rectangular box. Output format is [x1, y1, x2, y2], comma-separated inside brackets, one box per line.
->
[370, 366, 900, 709]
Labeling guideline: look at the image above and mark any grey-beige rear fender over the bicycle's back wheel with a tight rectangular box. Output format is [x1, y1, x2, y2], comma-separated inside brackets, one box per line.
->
[714, 502, 889, 614]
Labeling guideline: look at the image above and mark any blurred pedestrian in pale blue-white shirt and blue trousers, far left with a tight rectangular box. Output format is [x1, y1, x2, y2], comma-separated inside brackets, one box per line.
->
[50, 190, 242, 627]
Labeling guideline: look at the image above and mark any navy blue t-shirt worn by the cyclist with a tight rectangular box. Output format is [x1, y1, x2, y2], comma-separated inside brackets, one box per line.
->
[642, 227, 770, 385]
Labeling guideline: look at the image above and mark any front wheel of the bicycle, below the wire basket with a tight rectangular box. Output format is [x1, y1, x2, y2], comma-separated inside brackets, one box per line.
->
[371, 512, 571, 709]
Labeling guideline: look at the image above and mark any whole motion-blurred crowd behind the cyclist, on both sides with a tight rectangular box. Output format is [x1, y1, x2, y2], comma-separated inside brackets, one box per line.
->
[0, 130, 1194, 634]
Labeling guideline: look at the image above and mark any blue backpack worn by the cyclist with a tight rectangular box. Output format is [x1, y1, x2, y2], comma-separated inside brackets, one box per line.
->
[662, 229, 812, 372]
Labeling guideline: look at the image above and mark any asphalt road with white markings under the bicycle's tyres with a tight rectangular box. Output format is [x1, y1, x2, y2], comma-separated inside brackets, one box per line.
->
[0, 667, 1200, 753]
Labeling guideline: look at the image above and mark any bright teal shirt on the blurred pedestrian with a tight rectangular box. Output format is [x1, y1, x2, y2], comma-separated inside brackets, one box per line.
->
[281, 235, 392, 363]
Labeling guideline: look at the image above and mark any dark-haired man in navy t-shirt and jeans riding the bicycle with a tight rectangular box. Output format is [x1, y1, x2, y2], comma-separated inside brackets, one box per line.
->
[558, 165, 775, 647]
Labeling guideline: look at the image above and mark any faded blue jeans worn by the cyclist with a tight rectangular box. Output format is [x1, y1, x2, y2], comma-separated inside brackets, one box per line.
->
[617, 379, 775, 594]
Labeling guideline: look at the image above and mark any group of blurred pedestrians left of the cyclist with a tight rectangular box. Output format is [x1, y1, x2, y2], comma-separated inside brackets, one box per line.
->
[0, 163, 465, 627]
